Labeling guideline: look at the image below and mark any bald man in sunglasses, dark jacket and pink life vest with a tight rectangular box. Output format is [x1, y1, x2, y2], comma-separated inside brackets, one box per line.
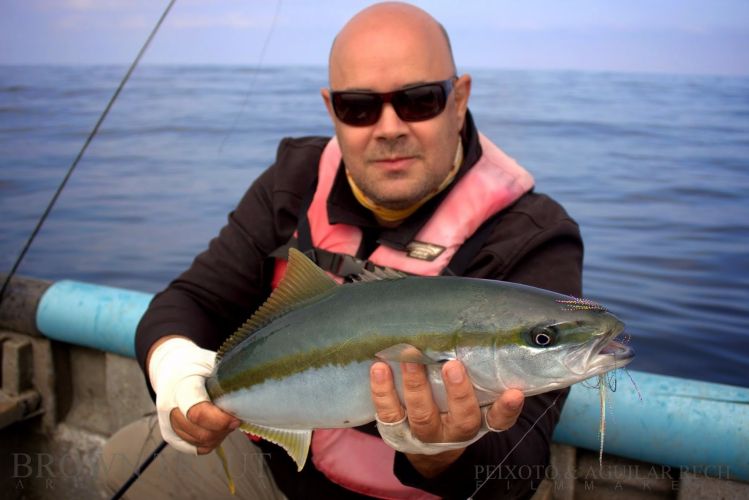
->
[101, 3, 582, 498]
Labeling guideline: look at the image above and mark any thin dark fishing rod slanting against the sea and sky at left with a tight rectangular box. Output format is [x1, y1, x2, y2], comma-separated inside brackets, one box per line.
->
[0, 0, 177, 304]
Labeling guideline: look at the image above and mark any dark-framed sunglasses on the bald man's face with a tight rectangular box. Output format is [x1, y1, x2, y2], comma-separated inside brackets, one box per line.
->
[330, 77, 455, 127]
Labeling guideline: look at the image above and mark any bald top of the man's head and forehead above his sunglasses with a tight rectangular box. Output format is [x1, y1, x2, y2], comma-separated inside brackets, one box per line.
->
[329, 2, 456, 88]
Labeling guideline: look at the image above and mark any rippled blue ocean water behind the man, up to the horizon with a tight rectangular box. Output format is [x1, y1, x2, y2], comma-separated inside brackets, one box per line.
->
[0, 66, 749, 386]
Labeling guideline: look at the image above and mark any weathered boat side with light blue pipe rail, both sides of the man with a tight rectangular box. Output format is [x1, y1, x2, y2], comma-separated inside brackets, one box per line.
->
[0, 277, 749, 500]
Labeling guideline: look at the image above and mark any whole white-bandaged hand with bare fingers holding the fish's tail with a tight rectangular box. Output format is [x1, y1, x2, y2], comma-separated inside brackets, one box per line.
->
[148, 337, 240, 455]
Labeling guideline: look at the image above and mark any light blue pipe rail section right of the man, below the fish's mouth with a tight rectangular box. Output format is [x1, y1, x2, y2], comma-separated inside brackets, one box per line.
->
[554, 370, 749, 481]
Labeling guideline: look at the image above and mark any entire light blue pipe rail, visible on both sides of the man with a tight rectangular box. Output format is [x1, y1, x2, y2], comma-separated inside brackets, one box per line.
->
[36, 280, 749, 481]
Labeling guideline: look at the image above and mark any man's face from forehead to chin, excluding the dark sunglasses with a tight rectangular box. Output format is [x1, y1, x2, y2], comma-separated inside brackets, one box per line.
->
[322, 18, 470, 209]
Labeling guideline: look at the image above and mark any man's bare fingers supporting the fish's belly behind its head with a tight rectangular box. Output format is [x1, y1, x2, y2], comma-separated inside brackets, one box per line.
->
[370, 361, 524, 477]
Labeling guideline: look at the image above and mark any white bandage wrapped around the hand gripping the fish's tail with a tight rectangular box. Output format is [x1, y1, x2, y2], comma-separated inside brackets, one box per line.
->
[148, 338, 216, 455]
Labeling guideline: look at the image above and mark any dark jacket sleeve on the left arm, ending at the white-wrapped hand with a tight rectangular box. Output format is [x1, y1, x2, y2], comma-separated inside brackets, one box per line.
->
[135, 139, 320, 397]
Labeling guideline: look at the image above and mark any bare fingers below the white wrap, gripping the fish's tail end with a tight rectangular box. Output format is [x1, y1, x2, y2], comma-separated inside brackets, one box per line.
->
[169, 401, 240, 455]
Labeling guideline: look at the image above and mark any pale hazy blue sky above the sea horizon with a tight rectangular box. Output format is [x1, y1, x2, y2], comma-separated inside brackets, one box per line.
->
[0, 0, 749, 75]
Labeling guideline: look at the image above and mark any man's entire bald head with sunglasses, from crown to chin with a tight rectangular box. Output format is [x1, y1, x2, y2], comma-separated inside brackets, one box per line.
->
[320, 2, 471, 212]
